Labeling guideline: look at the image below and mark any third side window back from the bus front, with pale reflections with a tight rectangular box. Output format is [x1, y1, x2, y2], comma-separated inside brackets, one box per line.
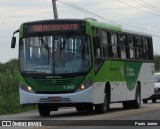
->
[111, 32, 118, 58]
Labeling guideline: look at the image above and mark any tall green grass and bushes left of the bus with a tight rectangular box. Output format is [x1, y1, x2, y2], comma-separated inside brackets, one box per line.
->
[0, 59, 35, 114]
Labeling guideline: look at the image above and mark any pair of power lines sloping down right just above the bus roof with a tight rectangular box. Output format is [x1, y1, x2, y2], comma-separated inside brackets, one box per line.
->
[58, 0, 160, 37]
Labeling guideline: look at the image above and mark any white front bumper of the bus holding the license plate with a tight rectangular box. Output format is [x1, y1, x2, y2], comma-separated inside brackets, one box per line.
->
[19, 87, 103, 105]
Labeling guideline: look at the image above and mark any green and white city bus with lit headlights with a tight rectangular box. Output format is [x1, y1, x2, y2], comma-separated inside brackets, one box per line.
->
[11, 19, 154, 116]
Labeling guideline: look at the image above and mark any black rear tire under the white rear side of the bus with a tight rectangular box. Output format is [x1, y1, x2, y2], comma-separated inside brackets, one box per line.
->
[132, 85, 141, 109]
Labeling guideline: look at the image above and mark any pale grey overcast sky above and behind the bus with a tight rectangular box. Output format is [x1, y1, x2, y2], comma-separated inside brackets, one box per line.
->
[0, 0, 160, 63]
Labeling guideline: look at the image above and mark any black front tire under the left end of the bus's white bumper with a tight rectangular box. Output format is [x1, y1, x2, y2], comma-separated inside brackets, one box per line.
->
[38, 104, 51, 116]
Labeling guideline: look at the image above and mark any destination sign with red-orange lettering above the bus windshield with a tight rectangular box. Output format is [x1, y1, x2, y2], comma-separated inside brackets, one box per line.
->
[24, 23, 85, 34]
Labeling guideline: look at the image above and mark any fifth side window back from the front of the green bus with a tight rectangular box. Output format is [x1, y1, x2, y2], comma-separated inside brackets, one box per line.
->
[127, 35, 135, 59]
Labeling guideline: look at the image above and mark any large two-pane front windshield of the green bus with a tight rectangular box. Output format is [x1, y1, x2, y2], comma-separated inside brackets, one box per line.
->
[19, 35, 91, 74]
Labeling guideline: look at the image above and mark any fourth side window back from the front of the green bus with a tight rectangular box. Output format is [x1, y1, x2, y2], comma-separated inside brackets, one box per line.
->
[119, 34, 127, 59]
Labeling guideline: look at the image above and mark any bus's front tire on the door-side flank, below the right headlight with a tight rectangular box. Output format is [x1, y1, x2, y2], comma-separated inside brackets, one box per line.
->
[95, 94, 109, 114]
